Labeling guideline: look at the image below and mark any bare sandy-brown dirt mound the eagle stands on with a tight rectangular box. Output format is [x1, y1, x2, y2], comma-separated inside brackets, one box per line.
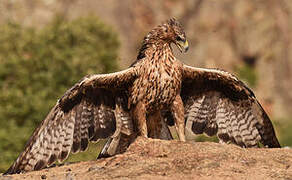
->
[0, 138, 292, 180]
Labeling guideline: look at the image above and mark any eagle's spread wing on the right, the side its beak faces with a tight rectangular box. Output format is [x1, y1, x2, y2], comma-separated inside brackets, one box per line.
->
[181, 65, 280, 147]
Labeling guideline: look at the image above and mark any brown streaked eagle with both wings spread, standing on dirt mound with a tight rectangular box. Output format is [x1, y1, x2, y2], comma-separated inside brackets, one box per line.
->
[6, 19, 280, 174]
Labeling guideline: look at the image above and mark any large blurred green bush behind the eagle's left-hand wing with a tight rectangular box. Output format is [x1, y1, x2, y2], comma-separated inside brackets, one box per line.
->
[0, 17, 119, 172]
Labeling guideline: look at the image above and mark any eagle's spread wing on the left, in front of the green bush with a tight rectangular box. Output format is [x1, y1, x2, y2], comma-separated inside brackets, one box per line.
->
[6, 68, 136, 174]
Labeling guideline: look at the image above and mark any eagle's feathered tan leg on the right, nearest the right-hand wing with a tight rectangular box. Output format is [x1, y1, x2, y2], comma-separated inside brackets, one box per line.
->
[171, 95, 186, 142]
